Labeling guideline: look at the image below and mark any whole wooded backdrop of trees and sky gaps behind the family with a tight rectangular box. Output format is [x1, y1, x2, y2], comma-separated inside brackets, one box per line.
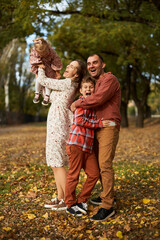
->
[0, 0, 160, 128]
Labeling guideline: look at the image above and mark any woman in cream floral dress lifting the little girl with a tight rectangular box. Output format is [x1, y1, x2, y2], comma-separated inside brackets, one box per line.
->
[38, 60, 86, 210]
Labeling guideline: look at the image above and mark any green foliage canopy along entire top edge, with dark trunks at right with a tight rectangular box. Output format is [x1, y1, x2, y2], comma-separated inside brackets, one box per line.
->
[0, 0, 160, 127]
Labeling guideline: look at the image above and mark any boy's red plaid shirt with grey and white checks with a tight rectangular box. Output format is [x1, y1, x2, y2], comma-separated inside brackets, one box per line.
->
[67, 108, 103, 153]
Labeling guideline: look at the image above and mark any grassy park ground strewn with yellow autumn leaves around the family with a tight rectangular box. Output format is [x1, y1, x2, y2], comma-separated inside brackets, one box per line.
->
[0, 121, 160, 240]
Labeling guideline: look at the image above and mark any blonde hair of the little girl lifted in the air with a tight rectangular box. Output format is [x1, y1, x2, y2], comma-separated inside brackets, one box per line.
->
[33, 37, 51, 56]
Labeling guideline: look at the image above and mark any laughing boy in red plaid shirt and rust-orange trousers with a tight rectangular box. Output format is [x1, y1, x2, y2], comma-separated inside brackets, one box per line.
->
[56, 76, 108, 216]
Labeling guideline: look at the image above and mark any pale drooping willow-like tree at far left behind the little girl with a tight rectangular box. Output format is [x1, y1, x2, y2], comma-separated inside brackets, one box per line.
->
[0, 39, 33, 123]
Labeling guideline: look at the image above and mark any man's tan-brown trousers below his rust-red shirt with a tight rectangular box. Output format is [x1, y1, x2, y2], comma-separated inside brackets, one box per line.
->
[96, 126, 119, 209]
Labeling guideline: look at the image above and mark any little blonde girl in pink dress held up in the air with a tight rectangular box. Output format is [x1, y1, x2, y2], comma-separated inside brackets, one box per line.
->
[29, 37, 62, 106]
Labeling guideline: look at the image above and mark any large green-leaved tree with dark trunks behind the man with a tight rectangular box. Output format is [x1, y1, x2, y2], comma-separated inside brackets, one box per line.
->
[50, 1, 160, 127]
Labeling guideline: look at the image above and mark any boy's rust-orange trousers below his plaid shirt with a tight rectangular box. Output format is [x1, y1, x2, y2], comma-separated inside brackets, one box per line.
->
[65, 145, 100, 208]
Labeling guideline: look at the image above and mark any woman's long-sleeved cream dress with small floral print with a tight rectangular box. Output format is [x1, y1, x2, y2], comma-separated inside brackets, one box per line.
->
[38, 68, 78, 167]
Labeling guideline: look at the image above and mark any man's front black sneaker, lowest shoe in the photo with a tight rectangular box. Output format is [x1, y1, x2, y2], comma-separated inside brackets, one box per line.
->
[90, 208, 115, 222]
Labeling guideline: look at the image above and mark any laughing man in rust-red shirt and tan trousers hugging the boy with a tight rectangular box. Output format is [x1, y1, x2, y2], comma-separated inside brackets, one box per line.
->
[71, 54, 121, 221]
